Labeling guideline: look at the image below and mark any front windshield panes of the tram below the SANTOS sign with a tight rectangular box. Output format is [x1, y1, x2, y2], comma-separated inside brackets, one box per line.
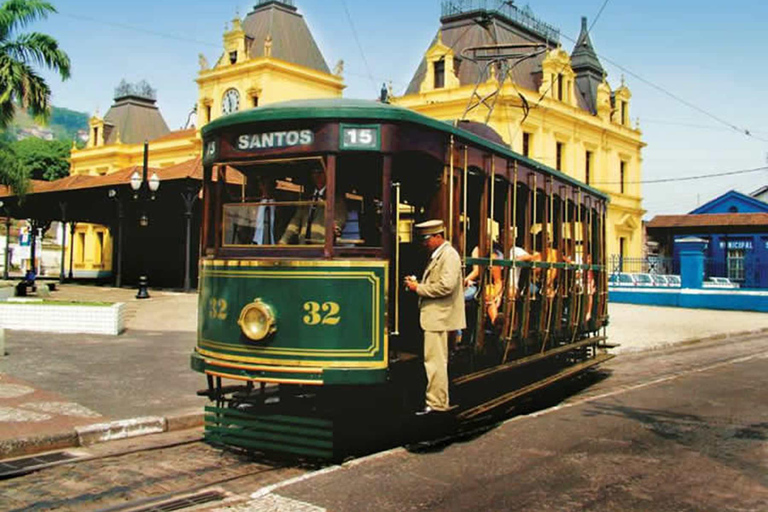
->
[222, 159, 381, 247]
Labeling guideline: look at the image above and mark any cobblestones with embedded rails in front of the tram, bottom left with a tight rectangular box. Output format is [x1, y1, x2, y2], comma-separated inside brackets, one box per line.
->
[0, 434, 307, 512]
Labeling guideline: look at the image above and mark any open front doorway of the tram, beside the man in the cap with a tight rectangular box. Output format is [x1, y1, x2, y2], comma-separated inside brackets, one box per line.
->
[390, 152, 443, 354]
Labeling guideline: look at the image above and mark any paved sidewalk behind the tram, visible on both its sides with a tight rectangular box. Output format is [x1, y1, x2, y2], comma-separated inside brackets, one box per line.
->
[0, 285, 768, 458]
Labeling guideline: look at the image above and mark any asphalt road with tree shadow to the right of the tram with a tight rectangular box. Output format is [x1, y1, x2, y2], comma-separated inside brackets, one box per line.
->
[260, 336, 768, 512]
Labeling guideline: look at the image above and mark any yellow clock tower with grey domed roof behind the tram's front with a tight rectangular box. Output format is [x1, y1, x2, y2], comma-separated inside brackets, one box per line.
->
[197, 0, 344, 128]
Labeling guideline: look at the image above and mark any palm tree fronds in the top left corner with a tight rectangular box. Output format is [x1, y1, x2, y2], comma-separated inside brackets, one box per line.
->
[0, 0, 70, 128]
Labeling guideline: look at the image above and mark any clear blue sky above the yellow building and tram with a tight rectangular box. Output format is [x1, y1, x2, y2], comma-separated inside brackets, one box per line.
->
[33, 0, 768, 219]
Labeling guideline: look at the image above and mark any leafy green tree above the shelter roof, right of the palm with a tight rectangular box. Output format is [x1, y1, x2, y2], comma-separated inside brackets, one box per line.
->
[11, 137, 70, 181]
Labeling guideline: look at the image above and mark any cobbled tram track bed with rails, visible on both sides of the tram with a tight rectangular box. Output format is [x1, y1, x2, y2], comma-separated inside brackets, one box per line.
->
[6, 337, 768, 512]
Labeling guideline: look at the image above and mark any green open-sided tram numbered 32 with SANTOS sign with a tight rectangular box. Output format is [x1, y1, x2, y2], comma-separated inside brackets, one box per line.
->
[191, 99, 611, 457]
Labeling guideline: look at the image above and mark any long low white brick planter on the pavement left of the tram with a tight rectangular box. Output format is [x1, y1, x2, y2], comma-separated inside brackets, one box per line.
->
[0, 301, 125, 335]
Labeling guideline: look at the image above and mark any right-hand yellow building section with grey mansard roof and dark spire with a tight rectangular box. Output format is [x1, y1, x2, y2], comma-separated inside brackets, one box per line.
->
[391, 4, 645, 258]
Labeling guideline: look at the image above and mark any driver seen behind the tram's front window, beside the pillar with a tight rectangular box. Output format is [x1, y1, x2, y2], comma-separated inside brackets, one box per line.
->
[279, 167, 347, 245]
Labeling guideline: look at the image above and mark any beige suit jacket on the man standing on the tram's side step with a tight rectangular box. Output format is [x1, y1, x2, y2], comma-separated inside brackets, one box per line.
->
[416, 245, 467, 331]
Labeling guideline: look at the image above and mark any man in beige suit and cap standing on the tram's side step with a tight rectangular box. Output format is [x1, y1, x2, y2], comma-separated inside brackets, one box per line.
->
[405, 220, 467, 414]
